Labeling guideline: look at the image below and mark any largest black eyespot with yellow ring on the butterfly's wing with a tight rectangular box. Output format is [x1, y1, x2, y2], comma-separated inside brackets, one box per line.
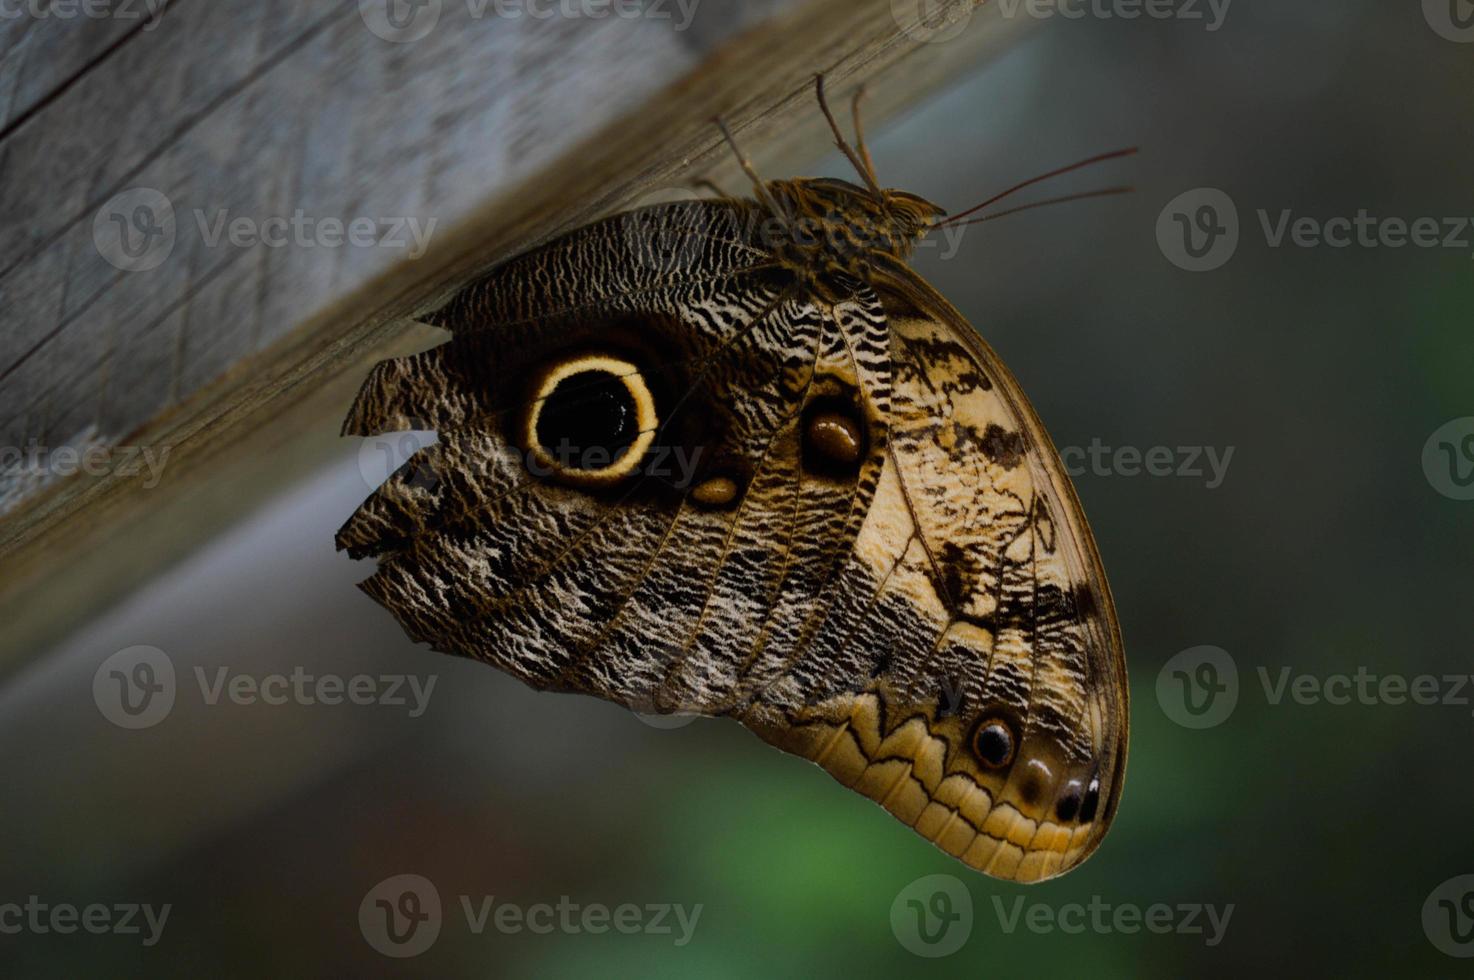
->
[523, 355, 657, 485]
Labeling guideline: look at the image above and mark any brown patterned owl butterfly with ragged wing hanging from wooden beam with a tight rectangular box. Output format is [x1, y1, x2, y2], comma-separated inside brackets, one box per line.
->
[338, 80, 1126, 881]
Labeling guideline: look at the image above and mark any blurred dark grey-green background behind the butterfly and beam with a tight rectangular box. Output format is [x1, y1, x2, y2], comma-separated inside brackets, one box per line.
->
[0, 0, 1474, 979]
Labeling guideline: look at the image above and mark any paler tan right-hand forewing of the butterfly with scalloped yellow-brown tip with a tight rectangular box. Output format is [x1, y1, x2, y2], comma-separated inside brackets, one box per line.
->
[737, 263, 1126, 881]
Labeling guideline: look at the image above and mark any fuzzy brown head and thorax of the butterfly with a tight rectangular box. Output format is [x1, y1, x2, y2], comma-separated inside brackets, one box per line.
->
[766, 178, 946, 283]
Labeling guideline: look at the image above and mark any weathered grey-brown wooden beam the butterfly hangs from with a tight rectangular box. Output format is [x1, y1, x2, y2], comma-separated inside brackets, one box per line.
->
[0, 0, 1023, 669]
